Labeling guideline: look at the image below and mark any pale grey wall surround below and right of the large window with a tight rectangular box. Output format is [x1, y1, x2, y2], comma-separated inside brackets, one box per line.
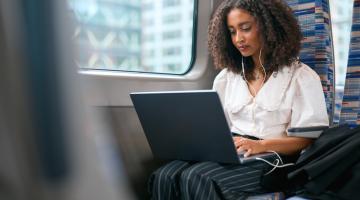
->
[78, 0, 217, 106]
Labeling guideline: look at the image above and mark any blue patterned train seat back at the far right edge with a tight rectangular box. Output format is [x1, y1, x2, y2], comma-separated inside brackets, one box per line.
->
[340, 0, 360, 127]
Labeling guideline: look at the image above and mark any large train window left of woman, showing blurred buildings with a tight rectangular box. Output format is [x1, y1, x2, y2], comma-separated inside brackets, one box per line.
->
[68, 0, 196, 74]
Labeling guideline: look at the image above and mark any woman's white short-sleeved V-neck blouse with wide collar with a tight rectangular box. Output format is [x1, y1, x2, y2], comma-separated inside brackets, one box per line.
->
[213, 62, 329, 139]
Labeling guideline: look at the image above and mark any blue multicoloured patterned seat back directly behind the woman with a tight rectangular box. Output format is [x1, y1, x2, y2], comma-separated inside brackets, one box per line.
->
[286, 0, 335, 123]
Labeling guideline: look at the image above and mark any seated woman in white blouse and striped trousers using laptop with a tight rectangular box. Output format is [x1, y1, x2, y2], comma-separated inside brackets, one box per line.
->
[150, 0, 329, 199]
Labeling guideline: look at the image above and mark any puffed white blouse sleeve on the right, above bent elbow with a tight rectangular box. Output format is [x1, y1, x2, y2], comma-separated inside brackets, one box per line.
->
[289, 65, 329, 136]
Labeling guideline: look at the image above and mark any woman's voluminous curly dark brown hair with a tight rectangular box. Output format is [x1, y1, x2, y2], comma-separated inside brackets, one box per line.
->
[208, 0, 302, 80]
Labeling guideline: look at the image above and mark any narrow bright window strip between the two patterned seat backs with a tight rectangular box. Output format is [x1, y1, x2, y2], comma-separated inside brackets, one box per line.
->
[329, 0, 354, 123]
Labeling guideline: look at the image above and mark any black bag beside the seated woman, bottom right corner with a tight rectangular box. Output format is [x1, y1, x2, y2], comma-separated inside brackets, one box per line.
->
[285, 125, 360, 199]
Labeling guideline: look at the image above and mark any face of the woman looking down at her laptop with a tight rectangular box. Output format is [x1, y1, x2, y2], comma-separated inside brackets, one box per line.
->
[227, 8, 261, 59]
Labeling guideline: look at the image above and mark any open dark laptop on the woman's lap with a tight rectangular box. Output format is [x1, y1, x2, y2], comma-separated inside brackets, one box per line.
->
[130, 90, 273, 163]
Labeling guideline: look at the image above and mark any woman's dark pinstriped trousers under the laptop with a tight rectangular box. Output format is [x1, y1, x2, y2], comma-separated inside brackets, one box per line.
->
[149, 160, 271, 200]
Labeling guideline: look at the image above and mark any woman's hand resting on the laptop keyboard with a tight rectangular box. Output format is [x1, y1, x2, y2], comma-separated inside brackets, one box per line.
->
[233, 137, 265, 157]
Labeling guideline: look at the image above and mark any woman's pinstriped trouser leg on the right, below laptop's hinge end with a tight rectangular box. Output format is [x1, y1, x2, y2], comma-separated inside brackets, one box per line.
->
[180, 162, 264, 199]
